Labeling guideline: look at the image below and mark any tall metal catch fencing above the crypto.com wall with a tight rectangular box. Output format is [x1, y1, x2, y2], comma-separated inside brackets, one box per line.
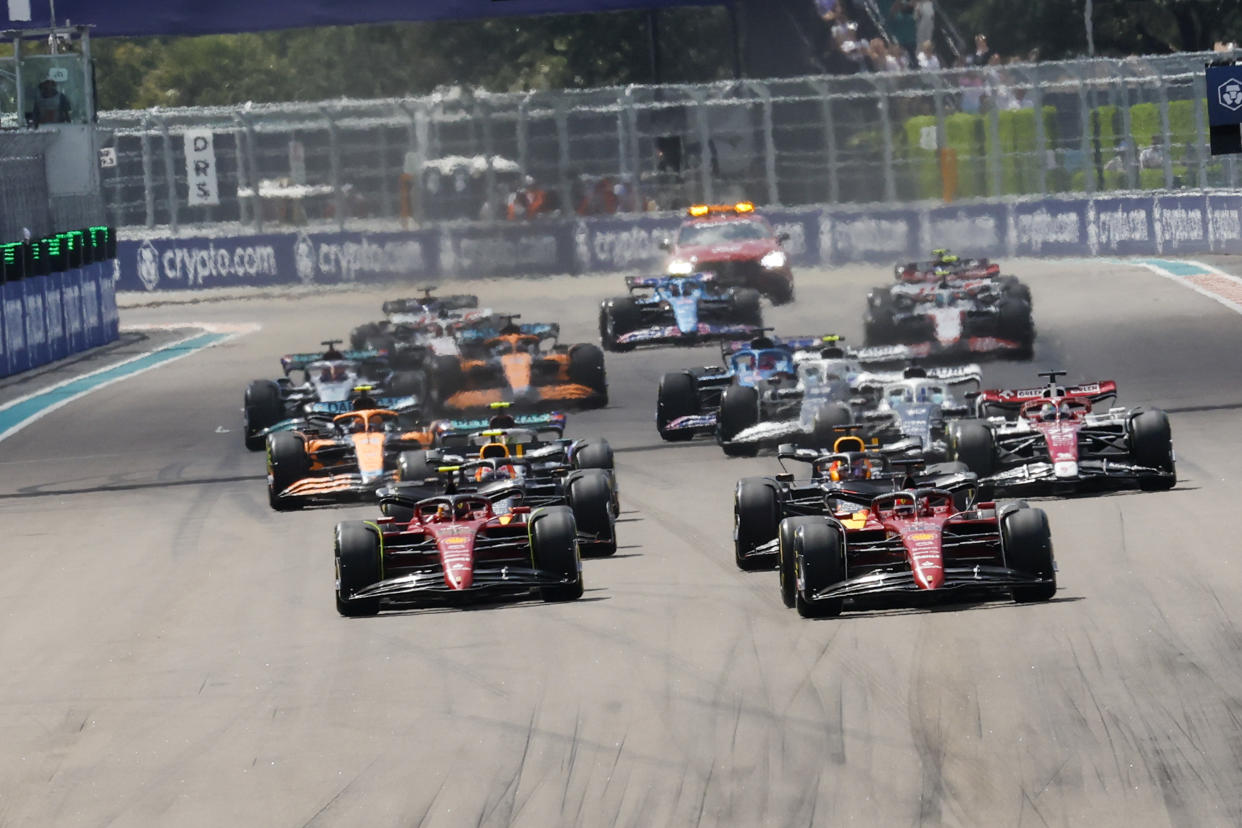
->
[99, 53, 1242, 231]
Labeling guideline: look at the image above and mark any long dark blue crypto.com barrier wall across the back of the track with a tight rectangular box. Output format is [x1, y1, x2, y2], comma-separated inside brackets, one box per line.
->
[117, 192, 1242, 290]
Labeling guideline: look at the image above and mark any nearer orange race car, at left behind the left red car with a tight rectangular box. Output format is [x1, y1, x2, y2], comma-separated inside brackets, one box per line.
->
[267, 396, 435, 511]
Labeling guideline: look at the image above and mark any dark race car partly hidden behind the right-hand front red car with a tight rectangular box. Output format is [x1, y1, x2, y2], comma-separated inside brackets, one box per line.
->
[733, 433, 979, 570]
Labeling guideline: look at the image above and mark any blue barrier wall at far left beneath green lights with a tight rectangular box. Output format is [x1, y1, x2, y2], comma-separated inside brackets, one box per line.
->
[0, 262, 120, 376]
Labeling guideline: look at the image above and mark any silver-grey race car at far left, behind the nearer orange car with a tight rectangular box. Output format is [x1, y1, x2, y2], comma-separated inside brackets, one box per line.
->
[242, 339, 426, 452]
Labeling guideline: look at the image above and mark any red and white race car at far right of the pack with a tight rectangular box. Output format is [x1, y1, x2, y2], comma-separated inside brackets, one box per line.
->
[948, 371, 1177, 494]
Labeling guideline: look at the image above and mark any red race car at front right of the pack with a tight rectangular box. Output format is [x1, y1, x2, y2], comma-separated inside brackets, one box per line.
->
[779, 488, 1057, 618]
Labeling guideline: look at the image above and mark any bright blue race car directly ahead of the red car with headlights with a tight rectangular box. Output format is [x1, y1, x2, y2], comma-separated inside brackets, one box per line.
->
[600, 273, 764, 351]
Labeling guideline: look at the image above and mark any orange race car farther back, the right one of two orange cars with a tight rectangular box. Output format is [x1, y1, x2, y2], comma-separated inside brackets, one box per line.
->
[432, 317, 609, 412]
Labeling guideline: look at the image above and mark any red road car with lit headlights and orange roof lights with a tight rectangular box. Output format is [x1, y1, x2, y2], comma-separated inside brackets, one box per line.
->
[660, 201, 794, 304]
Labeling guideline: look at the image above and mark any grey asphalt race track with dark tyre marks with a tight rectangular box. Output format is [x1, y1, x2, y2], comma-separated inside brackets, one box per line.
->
[0, 262, 1242, 827]
